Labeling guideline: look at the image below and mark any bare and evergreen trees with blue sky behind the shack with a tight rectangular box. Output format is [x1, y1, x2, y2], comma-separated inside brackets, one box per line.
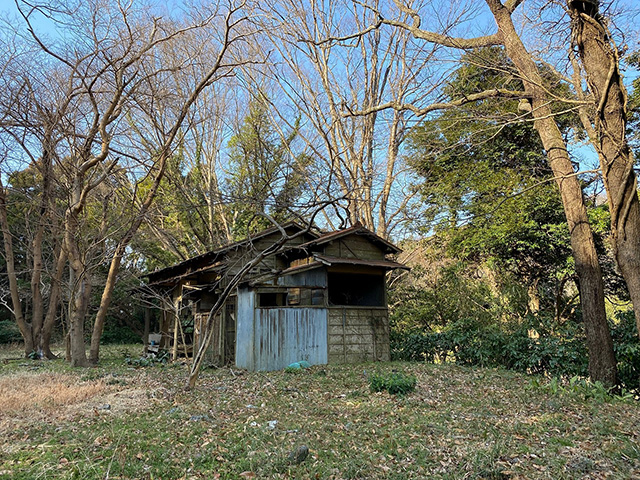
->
[0, 0, 640, 389]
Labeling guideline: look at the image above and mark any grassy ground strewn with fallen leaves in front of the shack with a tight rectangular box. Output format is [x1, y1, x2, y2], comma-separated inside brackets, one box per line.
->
[0, 346, 640, 480]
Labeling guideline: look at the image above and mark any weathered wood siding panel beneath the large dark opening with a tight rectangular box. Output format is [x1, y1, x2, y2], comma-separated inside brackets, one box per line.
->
[328, 307, 389, 363]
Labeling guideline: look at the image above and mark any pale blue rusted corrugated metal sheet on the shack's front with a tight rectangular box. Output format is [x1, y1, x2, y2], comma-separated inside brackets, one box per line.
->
[247, 307, 328, 370]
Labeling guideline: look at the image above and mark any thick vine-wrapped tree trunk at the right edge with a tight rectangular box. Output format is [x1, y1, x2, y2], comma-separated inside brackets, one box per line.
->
[569, 1, 640, 334]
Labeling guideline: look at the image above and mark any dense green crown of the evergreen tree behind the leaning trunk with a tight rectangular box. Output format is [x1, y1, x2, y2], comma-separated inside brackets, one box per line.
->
[409, 48, 575, 282]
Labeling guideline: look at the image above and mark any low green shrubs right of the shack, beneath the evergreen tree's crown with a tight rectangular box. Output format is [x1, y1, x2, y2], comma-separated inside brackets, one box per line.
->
[390, 251, 640, 390]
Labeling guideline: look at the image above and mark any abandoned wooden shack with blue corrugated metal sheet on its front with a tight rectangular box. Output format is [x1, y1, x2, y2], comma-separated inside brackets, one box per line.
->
[148, 222, 406, 370]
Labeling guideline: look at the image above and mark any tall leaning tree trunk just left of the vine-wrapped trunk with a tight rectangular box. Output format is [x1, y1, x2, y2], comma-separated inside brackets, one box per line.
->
[486, 0, 618, 386]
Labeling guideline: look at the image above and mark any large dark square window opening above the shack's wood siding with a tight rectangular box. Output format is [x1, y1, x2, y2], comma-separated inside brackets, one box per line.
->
[329, 272, 385, 307]
